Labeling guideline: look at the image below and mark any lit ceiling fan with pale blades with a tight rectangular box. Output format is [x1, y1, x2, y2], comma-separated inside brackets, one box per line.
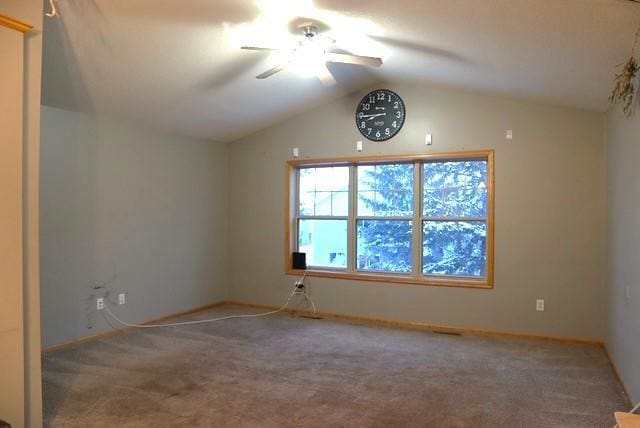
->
[242, 22, 382, 86]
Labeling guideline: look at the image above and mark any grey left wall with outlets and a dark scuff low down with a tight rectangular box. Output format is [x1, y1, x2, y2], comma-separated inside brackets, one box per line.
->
[41, 107, 228, 347]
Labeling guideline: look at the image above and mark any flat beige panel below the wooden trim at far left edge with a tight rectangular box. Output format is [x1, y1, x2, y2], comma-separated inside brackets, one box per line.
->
[0, 20, 25, 426]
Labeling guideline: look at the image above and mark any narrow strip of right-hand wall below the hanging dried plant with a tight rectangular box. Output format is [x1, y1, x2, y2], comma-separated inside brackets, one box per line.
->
[607, 105, 640, 403]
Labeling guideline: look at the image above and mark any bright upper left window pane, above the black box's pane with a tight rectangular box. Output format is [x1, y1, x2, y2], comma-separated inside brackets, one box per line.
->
[298, 166, 349, 216]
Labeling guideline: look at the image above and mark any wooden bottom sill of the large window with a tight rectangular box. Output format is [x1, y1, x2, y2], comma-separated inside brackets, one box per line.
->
[286, 269, 493, 289]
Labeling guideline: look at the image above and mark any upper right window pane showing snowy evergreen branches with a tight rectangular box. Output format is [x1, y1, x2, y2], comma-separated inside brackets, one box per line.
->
[423, 160, 488, 217]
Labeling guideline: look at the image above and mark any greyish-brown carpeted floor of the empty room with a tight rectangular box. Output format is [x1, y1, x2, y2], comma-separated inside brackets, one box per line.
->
[43, 306, 628, 428]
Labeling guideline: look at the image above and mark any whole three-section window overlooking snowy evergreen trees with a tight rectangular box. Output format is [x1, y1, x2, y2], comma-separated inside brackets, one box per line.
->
[286, 151, 494, 288]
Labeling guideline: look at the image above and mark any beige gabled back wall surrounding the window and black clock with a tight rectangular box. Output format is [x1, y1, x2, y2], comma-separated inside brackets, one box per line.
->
[230, 85, 606, 341]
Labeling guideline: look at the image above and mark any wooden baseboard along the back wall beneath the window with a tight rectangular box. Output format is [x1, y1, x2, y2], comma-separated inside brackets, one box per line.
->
[224, 300, 604, 347]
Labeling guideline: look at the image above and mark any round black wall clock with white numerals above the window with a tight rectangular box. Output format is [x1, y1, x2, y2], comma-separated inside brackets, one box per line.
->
[356, 89, 405, 141]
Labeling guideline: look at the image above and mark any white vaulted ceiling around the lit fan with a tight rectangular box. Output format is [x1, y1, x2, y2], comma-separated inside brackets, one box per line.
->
[43, 0, 640, 142]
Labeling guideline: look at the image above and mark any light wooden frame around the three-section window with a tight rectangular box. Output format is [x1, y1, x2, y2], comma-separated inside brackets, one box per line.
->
[285, 150, 495, 289]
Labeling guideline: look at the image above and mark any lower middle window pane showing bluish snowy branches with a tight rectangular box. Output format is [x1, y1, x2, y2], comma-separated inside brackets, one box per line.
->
[357, 220, 412, 272]
